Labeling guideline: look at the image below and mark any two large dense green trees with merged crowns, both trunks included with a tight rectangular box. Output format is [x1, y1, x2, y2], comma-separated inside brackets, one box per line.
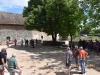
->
[23, 0, 84, 44]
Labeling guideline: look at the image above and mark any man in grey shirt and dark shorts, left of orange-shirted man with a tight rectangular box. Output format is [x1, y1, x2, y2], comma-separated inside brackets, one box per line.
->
[66, 47, 72, 75]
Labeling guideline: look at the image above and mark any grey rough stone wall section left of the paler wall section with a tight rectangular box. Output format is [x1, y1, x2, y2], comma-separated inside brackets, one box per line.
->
[0, 29, 32, 42]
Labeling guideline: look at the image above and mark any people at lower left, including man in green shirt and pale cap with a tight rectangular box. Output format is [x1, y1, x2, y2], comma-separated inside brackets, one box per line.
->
[0, 48, 22, 75]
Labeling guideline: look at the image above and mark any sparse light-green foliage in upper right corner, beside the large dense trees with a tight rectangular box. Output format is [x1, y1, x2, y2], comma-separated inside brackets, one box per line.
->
[80, 0, 100, 30]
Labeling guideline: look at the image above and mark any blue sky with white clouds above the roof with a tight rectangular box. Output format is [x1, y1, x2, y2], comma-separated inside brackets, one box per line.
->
[0, 0, 29, 14]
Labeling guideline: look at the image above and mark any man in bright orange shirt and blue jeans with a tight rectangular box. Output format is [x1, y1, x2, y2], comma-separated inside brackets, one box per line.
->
[79, 47, 88, 74]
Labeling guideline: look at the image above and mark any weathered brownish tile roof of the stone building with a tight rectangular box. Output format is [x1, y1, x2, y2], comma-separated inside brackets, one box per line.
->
[0, 11, 24, 25]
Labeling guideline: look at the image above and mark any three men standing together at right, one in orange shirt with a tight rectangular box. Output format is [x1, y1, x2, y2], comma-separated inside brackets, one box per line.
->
[66, 46, 88, 75]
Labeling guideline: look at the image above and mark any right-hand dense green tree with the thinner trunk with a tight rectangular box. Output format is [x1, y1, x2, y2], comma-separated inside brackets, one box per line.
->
[57, 0, 86, 43]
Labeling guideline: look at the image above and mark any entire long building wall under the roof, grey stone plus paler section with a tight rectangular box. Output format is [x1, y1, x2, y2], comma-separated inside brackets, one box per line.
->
[0, 25, 58, 43]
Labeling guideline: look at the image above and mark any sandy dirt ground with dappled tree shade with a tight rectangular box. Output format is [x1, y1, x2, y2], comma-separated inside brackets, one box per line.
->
[0, 45, 100, 75]
